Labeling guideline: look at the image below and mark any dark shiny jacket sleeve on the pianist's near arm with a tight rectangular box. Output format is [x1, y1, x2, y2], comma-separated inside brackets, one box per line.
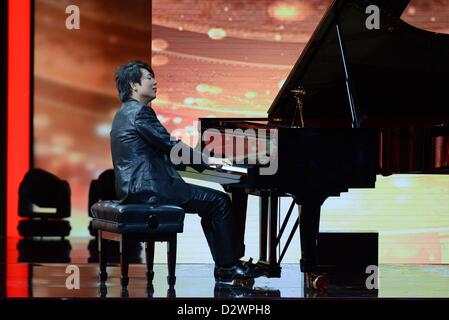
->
[135, 106, 207, 172]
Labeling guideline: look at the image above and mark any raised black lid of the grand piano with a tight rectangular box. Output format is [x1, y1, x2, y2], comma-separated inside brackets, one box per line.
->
[268, 0, 449, 126]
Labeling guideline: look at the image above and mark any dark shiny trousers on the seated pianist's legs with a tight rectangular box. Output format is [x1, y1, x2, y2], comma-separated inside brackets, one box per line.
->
[182, 184, 245, 267]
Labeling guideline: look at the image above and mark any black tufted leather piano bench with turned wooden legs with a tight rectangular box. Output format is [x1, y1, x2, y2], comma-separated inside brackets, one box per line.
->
[91, 200, 185, 292]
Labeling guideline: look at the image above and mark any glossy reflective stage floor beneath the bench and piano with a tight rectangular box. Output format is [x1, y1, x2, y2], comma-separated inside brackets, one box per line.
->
[2, 264, 449, 298]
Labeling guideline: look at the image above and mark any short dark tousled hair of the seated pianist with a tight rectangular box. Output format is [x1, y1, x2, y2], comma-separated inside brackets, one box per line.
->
[115, 60, 154, 102]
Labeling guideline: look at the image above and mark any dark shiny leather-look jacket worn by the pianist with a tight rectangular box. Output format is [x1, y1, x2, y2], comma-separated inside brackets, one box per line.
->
[110, 99, 206, 205]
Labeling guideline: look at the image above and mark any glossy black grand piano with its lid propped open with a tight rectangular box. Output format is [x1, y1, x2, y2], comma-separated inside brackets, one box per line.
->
[178, 0, 449, 284]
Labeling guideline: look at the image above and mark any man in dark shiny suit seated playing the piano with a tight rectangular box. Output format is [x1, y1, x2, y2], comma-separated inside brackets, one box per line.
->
[111, 61, 258, 282]
